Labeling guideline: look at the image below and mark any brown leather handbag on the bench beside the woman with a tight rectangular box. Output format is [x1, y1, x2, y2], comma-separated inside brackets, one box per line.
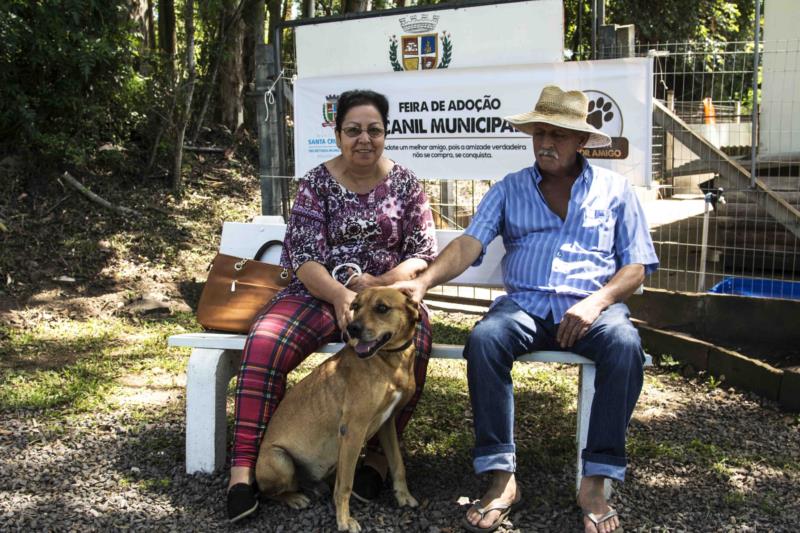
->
[197, 240, 292, 333]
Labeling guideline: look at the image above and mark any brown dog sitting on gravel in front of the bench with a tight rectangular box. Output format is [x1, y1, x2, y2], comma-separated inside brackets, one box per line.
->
[256, 287, 419, 532]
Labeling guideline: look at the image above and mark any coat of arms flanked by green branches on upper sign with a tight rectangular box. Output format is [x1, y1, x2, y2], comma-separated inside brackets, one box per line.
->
[389, 13, 453, 72]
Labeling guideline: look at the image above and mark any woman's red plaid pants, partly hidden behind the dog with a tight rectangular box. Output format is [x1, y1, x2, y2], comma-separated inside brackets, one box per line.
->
[231, 295, 431, 468]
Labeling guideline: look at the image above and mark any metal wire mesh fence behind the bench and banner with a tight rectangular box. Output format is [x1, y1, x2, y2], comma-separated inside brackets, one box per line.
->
[268, 32, 800, 299]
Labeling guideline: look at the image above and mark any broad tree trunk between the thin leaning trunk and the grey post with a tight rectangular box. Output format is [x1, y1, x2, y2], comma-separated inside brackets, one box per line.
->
[219, 1, 245, 131]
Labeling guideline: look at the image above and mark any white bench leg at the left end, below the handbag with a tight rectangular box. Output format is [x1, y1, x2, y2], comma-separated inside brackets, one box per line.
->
[186, 348, 237, 474]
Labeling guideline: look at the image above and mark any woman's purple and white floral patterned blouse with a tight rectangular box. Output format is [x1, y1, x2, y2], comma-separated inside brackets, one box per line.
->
[280, 164, 436, 296]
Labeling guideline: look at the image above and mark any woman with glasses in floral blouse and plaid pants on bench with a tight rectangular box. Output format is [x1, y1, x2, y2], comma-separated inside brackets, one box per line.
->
[228, 91, 436, 522]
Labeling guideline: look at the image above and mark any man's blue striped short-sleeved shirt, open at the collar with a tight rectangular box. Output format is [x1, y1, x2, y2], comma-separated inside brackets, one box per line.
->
[464, 155, 658, 322]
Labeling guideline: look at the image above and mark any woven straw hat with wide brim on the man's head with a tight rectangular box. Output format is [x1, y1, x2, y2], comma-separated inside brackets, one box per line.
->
[504, 85, 611, 148]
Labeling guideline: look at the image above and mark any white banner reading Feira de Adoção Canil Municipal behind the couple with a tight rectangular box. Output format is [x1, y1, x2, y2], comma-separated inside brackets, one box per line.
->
[294, 58, 653, 185]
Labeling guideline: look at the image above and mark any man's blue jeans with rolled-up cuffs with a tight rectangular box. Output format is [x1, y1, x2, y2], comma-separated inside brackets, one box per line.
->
[464, 298, 644, 481]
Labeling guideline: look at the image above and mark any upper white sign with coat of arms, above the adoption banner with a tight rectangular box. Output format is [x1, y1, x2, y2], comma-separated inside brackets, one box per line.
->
[295, 0, 564, 78]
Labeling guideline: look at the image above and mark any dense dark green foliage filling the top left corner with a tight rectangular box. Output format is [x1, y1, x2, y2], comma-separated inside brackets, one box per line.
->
[0, 0, 150, 165]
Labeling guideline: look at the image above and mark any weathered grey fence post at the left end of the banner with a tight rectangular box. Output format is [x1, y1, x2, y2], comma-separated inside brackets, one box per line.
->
[256, 44, 281, 215]
